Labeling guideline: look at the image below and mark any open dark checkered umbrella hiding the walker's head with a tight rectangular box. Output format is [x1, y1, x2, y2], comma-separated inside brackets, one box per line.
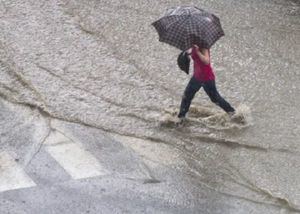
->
[152, 6, 224, 51]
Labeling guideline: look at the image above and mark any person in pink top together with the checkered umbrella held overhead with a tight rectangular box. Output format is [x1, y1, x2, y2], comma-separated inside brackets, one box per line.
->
[152, 6, 235, 121]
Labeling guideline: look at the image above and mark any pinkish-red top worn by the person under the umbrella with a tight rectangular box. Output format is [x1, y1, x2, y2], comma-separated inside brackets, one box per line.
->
[191, 48, 215, 82]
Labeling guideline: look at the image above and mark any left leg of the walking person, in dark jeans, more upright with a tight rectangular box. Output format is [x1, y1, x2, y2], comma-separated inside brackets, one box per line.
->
[178, 77, 201, 117]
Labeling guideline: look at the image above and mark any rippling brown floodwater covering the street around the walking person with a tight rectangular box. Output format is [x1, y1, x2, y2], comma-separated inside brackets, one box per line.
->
[0, 0, 300, 212]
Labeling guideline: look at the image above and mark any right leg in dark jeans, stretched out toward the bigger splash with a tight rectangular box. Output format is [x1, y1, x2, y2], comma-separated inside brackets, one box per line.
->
[203, 80, 235, 113]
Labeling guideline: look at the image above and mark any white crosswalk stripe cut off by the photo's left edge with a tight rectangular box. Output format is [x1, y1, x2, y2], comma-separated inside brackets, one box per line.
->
[0, 152, 36, 192]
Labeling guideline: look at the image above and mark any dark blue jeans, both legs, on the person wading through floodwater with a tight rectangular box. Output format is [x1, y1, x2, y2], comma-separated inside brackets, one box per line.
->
[178, 77, 235, 117]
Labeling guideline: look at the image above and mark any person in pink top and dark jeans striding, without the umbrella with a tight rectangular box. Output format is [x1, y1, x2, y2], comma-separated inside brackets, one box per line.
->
[178, 45, 235, 122]
